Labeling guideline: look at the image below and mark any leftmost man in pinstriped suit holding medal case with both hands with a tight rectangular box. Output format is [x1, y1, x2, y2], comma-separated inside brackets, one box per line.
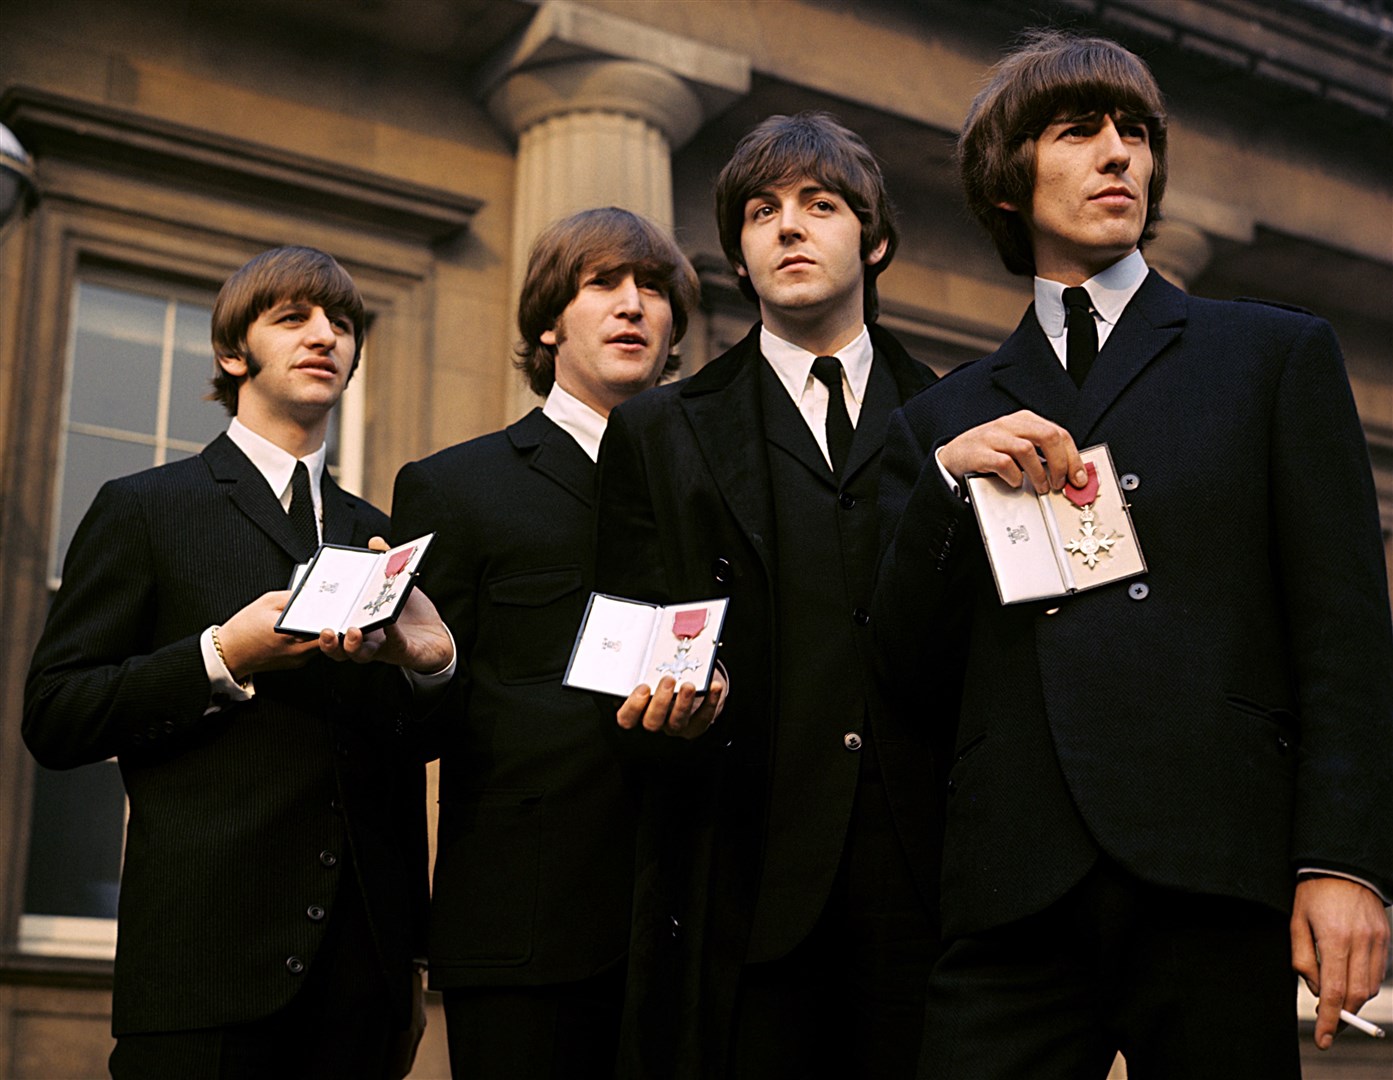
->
[24, 248, 453, 1080]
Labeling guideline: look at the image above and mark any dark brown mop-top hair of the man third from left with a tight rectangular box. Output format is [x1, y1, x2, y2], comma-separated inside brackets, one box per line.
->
[716, 113, 900, 322]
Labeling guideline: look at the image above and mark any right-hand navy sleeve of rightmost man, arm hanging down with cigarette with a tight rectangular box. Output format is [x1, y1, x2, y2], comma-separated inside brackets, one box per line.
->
[1269, 312, 1393, 896]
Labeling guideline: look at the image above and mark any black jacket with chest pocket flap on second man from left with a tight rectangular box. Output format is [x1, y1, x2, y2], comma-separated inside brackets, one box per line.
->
[393, 410, 638, 989]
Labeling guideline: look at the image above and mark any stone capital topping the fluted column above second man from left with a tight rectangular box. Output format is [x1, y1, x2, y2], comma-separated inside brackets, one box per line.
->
[479, 0, 749, 151]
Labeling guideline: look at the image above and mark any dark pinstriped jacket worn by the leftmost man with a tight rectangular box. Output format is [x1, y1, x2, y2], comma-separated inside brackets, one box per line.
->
[24, 435, 426, 1035]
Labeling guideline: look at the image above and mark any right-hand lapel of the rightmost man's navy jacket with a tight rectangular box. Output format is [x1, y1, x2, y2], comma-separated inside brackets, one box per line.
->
[1064, 270, 1185, 446]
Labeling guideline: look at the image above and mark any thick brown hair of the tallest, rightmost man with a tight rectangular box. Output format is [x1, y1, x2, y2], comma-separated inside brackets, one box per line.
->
[958, 29, 1166, 275]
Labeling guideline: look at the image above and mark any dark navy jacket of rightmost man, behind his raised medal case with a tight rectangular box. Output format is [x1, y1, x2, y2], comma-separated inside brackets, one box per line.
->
[875, 272, 1393, 934]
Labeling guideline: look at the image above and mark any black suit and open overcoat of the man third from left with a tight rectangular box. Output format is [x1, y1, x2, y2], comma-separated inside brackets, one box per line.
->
[596, 327, 936, 1076]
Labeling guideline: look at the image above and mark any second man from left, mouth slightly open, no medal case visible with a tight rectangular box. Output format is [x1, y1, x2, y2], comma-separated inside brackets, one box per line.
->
[393, 208, 698, 1080]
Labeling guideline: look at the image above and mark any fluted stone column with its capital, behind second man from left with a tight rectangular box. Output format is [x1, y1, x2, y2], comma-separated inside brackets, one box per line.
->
[485, 0, 749, 419]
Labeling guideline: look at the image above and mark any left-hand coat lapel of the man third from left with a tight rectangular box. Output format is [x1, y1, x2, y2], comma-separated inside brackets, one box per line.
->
[678, 323, 780, 573]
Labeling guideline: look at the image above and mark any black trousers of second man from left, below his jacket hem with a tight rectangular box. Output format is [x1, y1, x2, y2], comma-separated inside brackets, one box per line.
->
[444, 964, 624, 1080]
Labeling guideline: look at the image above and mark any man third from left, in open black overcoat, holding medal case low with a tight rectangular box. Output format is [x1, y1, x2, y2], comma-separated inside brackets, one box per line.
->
[596, 114, 936, 1079]
